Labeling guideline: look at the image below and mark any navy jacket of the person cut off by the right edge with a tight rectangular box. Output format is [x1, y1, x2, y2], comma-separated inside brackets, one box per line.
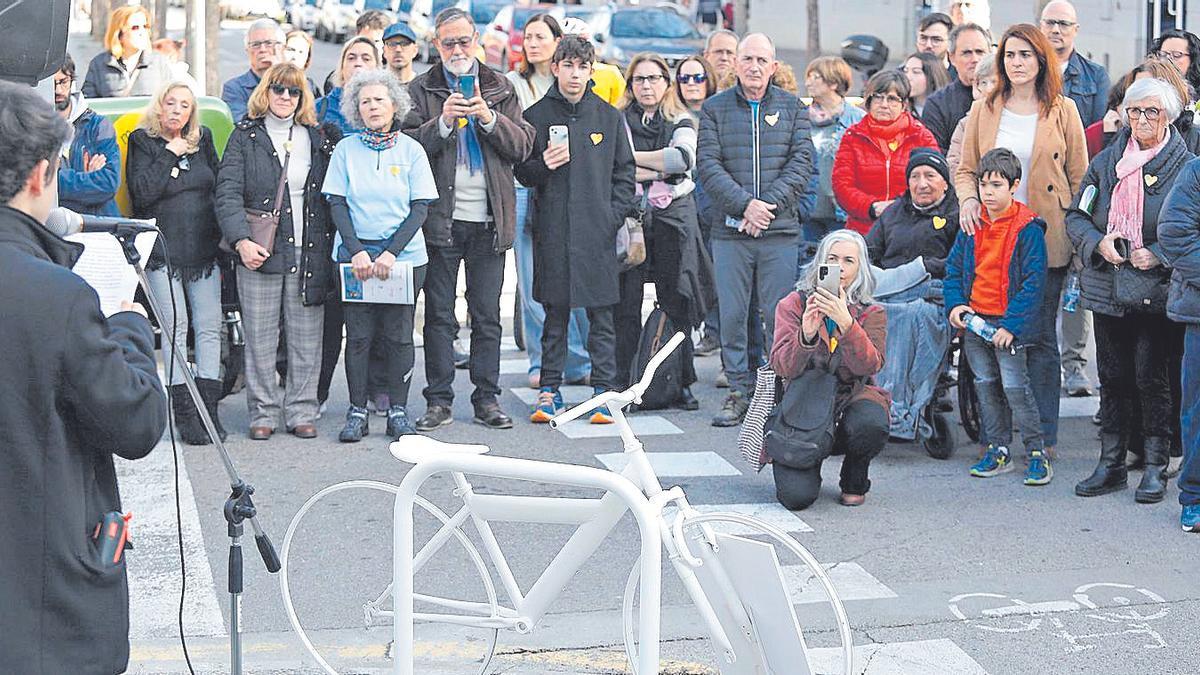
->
[1158, 160, 1200, 323]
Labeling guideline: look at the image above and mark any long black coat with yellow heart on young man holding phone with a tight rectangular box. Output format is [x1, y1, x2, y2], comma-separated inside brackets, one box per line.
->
[516, 85, 636, 307]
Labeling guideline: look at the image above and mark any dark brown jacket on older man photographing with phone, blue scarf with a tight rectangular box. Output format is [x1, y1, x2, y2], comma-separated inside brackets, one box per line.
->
[404, 65, 533, 253]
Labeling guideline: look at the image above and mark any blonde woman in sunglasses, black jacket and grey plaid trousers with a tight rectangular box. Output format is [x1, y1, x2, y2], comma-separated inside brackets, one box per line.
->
[216, 63, 343, 441]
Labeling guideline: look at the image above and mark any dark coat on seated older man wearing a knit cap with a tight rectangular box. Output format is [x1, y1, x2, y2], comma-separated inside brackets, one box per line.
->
[866, 187, 959, 279]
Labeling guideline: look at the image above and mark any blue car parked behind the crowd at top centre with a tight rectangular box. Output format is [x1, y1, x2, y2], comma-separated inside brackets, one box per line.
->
[594, 7, 704, 68]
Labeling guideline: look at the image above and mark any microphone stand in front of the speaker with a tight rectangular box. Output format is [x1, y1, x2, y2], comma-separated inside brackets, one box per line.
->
[112, 225, 280, 675]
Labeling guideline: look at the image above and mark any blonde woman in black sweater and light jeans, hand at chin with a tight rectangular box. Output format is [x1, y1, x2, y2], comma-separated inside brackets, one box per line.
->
[125, 80, 223, 446]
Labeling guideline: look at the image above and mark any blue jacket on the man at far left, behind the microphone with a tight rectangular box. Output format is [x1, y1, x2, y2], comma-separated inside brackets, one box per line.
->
[59, 94, 121, 216]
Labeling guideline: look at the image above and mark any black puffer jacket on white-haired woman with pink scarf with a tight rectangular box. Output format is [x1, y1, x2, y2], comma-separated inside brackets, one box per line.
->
[1067, 127, 1194, 316]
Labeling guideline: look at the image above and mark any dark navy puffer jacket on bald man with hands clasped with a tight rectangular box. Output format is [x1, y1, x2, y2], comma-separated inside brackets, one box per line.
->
[696, 85, 816, 239]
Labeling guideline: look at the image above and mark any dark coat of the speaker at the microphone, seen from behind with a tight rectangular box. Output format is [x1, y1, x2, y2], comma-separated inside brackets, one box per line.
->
[0, 207, 167, 675]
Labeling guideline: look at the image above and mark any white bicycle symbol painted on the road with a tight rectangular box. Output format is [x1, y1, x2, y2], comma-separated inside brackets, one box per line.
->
[949, 581, 1169, 652]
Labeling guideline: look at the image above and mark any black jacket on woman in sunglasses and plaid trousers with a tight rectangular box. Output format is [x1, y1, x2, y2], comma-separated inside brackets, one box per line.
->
[216, 118, 341, 305]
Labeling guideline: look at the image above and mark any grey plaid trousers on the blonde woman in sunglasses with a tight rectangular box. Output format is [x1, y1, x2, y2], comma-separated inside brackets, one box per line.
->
[238, 261, 325, 429]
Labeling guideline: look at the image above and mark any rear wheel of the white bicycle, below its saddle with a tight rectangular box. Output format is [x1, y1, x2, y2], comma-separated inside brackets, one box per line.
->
[280, 480, 500, 675]
